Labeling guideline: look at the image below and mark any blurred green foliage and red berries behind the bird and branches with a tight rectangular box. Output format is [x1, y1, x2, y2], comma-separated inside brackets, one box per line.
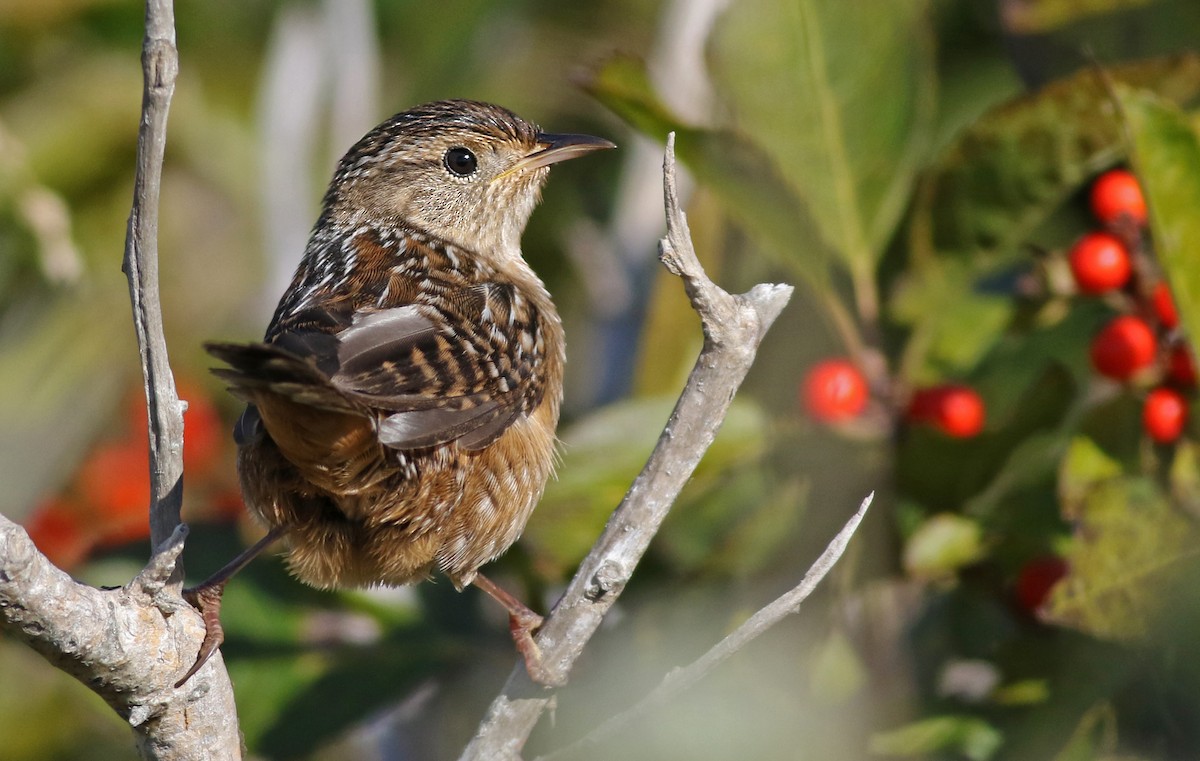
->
[0, 0, 1200, 761]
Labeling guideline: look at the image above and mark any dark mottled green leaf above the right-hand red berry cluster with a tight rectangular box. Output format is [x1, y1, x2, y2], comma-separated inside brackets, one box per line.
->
[912, 55, 1200, 266]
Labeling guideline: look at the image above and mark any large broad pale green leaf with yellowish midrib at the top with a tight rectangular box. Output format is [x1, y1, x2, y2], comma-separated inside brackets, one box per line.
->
[710, 0, 936, 276]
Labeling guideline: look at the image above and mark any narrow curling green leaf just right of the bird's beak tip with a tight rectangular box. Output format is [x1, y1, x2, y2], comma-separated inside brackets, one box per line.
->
[584, 56, 830, 284]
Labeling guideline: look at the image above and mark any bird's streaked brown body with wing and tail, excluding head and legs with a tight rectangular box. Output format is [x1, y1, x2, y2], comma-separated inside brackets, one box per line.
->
[209, 219, 563, 587]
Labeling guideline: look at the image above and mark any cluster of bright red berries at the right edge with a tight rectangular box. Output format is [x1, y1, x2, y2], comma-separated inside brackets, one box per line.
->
[1068, 169, 1196, 444]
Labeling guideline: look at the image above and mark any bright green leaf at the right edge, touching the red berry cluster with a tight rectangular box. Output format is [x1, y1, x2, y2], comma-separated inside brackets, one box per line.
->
[1116, 85, 1200, 343]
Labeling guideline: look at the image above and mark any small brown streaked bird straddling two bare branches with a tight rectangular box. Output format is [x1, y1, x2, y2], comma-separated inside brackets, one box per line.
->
[179, 101, 614, 684]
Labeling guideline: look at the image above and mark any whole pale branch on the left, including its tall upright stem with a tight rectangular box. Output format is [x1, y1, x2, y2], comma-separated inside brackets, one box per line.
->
[0, 0, 241, 761]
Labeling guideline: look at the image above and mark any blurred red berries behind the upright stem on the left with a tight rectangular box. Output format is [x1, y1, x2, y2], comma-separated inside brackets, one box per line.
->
[25, 382, 240, 569]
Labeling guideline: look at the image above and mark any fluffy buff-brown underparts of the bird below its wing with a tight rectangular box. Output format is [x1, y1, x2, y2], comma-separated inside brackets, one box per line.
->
[239, 409, 557, 588]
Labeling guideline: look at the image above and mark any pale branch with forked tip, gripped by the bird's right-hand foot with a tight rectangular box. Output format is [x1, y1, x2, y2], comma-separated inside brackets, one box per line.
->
[460, 133, 792, 761]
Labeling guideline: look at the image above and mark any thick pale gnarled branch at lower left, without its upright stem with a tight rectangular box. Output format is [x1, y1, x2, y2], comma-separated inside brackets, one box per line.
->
[0, 515, 241, 761]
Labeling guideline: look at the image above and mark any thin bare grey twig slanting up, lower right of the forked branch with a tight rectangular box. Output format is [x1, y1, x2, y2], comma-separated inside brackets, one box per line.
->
[538, 492, 875, 761]
